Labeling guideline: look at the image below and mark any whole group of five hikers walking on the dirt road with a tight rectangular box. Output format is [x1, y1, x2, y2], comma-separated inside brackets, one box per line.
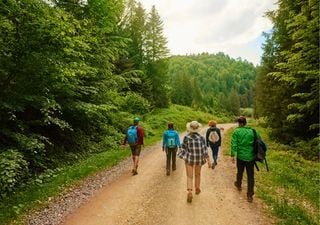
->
[122, 116, 260, 203]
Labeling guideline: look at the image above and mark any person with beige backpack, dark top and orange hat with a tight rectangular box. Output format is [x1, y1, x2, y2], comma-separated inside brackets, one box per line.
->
[206, 120, 221, 169]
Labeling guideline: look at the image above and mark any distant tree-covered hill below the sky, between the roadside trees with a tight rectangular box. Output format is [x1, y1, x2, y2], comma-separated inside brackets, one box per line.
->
[167, 53, 256, 115]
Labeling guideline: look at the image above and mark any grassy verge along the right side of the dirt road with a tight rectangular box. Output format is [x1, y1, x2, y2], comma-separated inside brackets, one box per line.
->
[224, 124, 320, 225]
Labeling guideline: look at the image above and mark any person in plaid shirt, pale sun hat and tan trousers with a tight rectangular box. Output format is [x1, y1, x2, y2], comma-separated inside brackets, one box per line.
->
[178, 121, 211, 203]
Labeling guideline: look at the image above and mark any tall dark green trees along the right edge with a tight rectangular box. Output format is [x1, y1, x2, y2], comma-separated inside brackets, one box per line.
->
[256, 0, 320, 158]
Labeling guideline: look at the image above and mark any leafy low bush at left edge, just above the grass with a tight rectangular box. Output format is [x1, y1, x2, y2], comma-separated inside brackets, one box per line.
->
[0, 149, 28, 197]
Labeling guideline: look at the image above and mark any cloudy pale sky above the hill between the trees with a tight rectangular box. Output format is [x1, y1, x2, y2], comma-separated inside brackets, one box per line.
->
[138, 0, 276, 65]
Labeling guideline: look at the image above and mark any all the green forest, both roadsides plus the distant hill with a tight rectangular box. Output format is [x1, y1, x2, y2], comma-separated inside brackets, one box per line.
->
[0, 0, 319, 196]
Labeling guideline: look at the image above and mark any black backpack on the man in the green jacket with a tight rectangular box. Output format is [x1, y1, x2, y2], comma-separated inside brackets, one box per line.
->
[252, 129, 269, 171]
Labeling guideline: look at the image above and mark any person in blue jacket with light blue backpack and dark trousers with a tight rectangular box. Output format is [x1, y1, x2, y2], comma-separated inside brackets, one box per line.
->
[162, 122, 181, 176]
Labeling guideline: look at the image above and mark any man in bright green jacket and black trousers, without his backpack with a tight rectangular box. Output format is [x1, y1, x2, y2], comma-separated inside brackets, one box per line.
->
[231, 116, 260, 202]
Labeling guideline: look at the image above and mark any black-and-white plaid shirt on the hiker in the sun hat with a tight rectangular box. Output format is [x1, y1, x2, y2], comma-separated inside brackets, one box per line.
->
[182, 133, 209, 165]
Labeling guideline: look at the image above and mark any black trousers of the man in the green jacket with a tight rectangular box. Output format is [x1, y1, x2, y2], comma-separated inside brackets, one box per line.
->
[236, 158, 254, 197]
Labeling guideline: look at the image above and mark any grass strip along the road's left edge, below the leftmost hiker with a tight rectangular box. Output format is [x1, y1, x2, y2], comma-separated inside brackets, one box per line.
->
[0, 150, 130, 225]
